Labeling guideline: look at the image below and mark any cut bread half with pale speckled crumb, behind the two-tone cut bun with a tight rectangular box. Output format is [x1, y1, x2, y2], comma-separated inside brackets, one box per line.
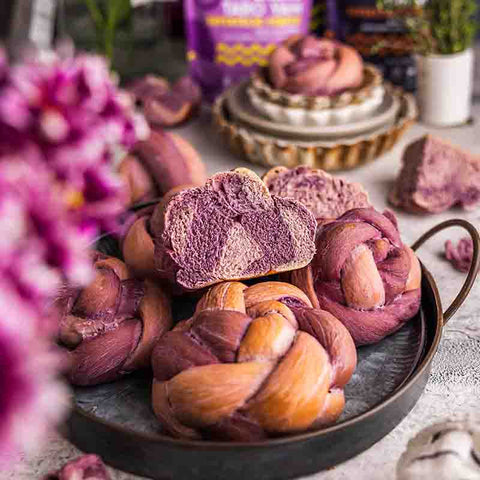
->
[264, 166, 371, 220]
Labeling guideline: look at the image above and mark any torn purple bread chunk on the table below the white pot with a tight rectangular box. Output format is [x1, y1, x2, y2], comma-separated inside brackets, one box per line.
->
[389, 135, 480, 213]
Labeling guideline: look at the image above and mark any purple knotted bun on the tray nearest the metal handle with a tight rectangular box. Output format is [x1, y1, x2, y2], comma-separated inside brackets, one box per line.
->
[286, 208, 421, 345]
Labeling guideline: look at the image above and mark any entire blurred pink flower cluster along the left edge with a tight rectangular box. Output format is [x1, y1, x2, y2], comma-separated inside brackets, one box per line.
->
[0, 47, 148, 464]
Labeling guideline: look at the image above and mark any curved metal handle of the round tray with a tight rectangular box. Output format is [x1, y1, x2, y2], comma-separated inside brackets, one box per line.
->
[412, 218, 480, 325]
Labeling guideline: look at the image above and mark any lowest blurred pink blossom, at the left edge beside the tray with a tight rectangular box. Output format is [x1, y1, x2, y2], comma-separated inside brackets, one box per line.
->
[0, 279, 68, 463]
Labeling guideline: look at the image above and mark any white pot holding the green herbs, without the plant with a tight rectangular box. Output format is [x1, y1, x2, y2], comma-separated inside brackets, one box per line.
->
[417, 48, 474, 127]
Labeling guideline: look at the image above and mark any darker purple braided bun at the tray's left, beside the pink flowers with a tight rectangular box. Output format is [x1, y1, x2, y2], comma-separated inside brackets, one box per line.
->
[58, 255, 172, 385]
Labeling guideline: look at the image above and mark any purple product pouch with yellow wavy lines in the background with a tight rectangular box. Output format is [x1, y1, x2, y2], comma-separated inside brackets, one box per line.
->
[185, 0, 311, 101]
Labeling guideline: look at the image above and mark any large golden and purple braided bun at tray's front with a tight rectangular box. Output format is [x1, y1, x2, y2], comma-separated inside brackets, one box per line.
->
[152, 282, 356, 440]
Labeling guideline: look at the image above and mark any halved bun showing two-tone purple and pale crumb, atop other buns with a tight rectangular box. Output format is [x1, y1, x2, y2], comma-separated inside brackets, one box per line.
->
[151, 168, 316, 290]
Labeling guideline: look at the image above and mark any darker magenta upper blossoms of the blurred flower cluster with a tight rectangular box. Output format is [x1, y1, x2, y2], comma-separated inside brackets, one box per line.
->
[0, 49, 148, 230]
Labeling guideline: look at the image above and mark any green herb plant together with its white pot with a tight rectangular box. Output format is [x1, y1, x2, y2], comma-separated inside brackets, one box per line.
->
[382, 0, 477, 126]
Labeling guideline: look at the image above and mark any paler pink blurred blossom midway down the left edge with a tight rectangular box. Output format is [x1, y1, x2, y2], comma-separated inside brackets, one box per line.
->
[0, 157, 95, 312]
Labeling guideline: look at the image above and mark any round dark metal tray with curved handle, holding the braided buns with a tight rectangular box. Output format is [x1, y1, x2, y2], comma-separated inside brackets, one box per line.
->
[67, 220, 480, 480]
